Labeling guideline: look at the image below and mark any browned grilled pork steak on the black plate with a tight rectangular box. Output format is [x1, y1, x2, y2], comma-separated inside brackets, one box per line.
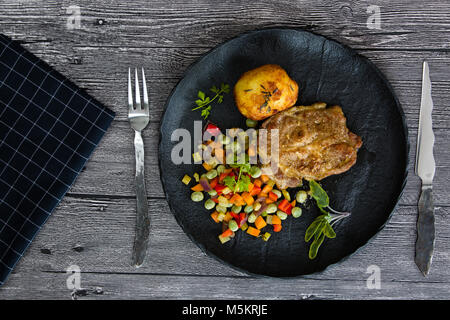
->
[258, 103, 362, 189]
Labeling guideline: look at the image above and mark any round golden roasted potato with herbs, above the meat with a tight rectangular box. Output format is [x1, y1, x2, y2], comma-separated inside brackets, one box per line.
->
[234, 64, 298, 120]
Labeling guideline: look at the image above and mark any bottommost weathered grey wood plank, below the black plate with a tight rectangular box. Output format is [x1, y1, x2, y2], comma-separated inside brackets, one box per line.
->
[0, 270, 449, 300]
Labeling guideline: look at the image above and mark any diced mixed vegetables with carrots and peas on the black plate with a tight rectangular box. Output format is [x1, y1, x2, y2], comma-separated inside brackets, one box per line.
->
[182, 123, 308, 243]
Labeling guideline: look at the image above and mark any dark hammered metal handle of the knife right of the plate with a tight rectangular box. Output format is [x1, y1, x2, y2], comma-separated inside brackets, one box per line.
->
[415, 185, 435, 275]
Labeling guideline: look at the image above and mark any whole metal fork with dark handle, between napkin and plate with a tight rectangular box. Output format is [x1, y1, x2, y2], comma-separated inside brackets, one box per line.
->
[128, 68, 150, 267]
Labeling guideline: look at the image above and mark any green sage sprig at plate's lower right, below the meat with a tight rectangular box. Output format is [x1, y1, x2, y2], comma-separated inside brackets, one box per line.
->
[305, 180, 350, 259]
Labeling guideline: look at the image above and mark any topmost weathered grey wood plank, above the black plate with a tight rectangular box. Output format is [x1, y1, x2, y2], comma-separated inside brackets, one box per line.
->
[0, 0, 450, 50]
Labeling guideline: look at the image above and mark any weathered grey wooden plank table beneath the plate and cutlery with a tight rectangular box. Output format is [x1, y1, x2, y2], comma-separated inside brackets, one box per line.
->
[0, 0, 450, 299]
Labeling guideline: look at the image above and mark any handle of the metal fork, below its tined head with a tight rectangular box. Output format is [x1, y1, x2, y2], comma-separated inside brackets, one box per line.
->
[132, 130, 150, 267]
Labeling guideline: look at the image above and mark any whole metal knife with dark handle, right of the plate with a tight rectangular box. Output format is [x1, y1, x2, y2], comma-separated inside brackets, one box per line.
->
[414, 61, 436, 276]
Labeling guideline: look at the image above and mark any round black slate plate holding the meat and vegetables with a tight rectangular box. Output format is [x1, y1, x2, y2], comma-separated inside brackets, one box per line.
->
[159, 29, 409, 277]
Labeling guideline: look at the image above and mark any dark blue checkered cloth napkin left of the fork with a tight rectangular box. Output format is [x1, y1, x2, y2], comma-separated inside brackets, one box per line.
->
[0, 34, 114, 285]
